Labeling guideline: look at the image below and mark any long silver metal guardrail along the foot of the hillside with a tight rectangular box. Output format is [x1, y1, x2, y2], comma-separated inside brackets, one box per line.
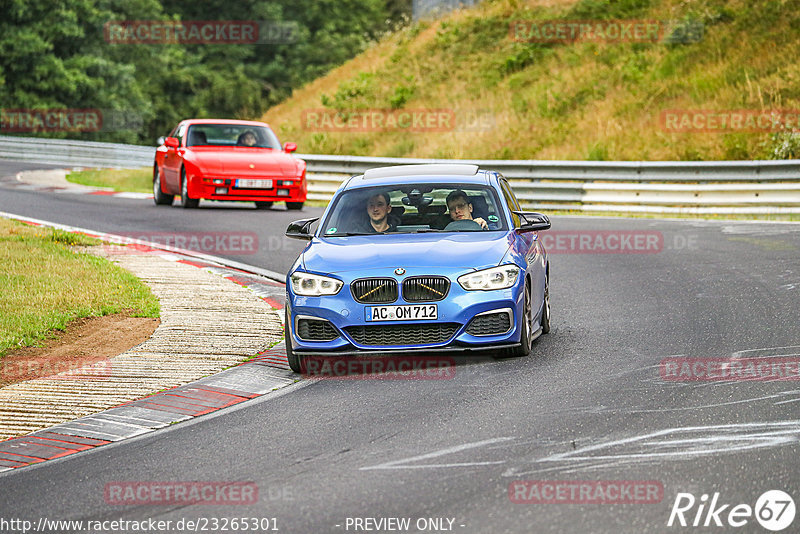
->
[0, 136, 800, 213]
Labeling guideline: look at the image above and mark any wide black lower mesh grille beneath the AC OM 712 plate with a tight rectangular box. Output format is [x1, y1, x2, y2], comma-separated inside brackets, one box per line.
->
[345, 323, 460, 347]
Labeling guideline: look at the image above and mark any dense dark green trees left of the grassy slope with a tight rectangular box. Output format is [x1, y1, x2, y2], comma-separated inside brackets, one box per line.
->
[0, 0, 400, 143]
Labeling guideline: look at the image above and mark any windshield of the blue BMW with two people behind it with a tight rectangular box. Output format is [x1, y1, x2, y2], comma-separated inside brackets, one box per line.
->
[321, 184, 507, 237]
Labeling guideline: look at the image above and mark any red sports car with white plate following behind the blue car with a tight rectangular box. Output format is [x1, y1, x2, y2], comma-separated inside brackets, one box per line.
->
[153, 119, 307, 210]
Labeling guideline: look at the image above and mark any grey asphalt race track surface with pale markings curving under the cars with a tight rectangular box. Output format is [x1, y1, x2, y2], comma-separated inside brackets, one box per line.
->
[0, 162, 800, 533]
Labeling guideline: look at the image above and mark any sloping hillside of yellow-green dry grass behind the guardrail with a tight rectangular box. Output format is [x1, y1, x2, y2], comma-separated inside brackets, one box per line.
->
[264, 0, 800, 160]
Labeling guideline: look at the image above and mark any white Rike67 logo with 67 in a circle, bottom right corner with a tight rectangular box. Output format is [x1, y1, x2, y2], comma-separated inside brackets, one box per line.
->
[667, 490, 795, 532]
